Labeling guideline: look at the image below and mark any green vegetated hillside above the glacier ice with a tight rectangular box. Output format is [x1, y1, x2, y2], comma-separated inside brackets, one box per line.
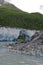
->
[0, 6, 43, 30]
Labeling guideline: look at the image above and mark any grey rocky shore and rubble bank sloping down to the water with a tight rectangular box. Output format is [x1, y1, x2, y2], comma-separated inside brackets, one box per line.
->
[7, 31, 43, 56]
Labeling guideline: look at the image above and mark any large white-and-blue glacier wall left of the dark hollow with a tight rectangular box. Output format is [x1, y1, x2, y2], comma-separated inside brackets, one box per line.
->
[0, 27, 19, 41]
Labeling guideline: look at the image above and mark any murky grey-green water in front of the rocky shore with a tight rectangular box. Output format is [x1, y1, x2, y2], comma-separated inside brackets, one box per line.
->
[0, 42, 43, 65]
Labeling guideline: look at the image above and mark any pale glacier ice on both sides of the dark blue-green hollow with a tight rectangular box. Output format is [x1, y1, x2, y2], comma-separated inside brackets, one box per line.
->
[0, 27, 35, 41]
